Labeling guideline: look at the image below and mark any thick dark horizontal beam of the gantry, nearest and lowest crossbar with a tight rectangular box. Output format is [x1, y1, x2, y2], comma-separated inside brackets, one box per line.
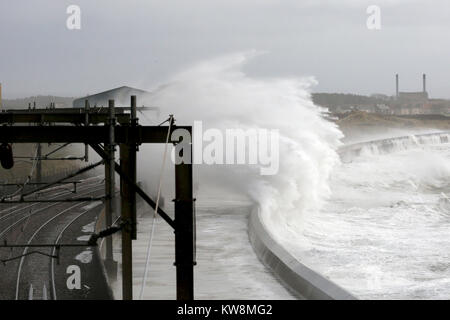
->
[0, 126, 192, 144]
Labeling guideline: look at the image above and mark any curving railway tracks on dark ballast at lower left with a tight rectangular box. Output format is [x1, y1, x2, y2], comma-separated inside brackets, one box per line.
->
[0, 178, 108, 300]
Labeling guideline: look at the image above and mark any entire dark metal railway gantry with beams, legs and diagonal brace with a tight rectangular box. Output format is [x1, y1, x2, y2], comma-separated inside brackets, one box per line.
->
[0, 96, 196, 300]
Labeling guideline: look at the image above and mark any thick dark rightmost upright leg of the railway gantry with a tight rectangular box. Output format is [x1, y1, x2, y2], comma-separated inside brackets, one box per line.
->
[175, 132, 195, 300]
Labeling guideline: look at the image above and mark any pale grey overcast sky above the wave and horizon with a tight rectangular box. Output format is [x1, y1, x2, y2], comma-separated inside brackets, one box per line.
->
[0, 0, 450, 98]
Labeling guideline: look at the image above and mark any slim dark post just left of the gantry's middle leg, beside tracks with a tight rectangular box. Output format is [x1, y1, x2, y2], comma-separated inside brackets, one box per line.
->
[105, 100, 115, 263]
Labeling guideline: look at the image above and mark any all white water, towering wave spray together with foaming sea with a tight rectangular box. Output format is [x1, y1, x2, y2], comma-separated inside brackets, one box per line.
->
[135, 53, 450, 298]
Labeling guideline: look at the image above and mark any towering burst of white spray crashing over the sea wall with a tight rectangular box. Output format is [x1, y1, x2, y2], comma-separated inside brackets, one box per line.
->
[139, 52, 342, 235]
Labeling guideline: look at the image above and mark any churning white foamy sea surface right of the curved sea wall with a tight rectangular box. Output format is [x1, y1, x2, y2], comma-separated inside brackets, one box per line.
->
[285, 144, 450, 299]
